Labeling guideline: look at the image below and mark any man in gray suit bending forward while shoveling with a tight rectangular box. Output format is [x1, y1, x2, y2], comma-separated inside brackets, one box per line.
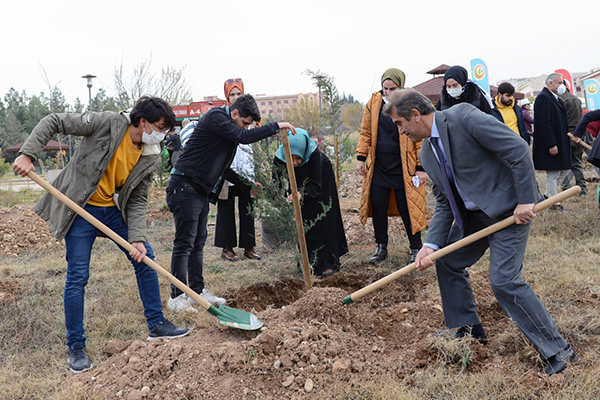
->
[384, 89, 576, 375]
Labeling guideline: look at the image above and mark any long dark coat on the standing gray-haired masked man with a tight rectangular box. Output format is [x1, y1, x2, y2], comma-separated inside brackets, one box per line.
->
[533, 88, 571, 171]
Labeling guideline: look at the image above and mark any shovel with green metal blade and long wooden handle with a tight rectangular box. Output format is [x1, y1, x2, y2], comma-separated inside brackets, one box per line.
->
[27, 172, 263, 331]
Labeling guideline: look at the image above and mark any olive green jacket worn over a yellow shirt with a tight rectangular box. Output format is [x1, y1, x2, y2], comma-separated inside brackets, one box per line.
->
[20, 112, 160, 243]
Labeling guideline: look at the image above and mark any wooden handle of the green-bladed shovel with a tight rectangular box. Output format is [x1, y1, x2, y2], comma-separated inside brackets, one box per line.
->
[27, 171, 211, 310]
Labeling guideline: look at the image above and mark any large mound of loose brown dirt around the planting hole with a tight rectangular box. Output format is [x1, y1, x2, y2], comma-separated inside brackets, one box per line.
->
[66, 271, 536, 399]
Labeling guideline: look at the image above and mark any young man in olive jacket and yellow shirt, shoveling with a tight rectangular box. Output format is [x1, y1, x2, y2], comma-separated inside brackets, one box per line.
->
[13, 96, 189, 373]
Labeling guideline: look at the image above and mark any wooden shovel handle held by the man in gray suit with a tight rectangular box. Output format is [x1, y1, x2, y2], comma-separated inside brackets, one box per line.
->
[344, 186, 581, 304]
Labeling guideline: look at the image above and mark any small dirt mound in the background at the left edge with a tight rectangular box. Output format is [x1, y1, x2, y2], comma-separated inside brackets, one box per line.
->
[0, 205, 63, 257]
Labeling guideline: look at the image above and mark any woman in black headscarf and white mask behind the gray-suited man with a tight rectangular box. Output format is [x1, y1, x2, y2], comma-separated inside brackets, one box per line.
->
[436, 65, 492, 114]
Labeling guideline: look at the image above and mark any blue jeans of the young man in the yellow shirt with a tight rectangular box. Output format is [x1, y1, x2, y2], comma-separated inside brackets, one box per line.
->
[64, 204, 164, 348]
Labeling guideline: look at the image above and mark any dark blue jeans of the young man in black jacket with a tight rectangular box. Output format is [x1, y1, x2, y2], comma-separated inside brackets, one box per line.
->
[167, 175, 210, 298]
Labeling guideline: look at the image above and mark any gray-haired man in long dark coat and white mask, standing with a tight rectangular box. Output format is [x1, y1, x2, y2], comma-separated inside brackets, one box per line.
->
[533, 73, 571, 211]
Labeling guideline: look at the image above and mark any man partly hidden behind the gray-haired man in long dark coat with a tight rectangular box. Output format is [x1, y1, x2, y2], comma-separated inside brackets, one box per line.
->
[559, 82, 587, 196]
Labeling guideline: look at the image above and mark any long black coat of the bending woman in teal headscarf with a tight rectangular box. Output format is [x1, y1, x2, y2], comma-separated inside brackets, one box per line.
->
[273, 149, 348, 275]
